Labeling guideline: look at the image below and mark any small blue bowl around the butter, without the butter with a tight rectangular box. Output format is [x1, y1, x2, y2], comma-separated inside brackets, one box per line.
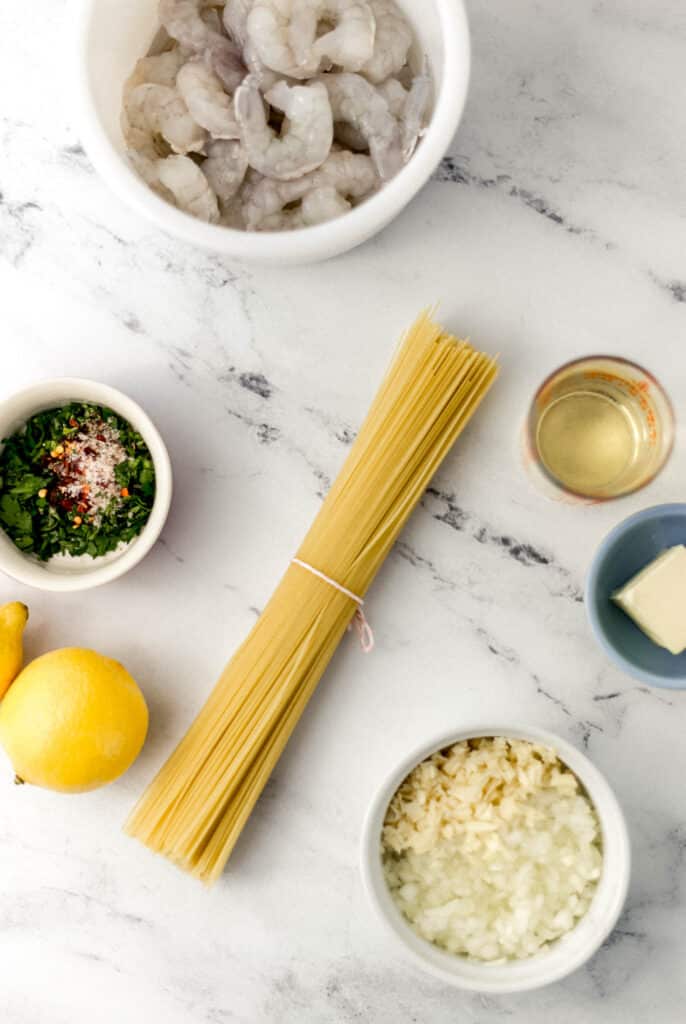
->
[586, 505, 686, 689]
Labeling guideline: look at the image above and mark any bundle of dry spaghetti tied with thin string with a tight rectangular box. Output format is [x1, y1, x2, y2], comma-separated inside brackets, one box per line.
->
[126, 312, 497, 883]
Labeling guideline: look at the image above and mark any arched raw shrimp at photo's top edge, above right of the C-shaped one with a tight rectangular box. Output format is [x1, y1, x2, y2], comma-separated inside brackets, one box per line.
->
[289, 0, 376, 71]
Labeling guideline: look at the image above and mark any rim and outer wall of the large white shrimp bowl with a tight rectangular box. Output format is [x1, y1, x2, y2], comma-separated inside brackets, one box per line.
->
[70, 0, 471, 264]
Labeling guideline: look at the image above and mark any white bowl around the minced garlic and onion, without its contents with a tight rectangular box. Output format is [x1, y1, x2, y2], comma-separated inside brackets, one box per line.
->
[361, 722, 631, 993]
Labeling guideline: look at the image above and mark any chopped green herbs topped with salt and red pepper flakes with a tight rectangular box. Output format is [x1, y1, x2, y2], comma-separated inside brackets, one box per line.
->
[0, 402, 155, 561]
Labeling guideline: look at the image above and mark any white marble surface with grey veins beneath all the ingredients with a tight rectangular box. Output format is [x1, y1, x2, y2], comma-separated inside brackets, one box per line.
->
[0, 0, 686, 1024]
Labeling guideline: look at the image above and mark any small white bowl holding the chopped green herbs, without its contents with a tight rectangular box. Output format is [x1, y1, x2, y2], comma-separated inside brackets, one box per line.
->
[0, 377, 172, 593]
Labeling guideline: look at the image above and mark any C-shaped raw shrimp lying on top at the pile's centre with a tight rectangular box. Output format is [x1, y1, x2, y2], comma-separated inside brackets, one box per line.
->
[234, 76, 334, 181]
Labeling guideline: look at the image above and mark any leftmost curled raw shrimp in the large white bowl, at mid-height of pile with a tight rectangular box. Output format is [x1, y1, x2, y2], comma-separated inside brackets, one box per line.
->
[122, 83, 207, 154]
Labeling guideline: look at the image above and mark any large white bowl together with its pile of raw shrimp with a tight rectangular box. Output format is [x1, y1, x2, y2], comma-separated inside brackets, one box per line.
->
[72, 0, 470, 265]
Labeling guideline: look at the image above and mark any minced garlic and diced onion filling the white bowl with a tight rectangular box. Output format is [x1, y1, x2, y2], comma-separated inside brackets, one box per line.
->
[382, 736, 602, 962]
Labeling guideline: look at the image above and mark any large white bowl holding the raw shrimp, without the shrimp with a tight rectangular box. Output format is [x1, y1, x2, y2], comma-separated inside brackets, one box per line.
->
[70, 0, 470, 265]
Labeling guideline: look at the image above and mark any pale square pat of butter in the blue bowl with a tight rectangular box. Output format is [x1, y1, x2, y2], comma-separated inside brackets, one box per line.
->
[612, 544, 686, 654]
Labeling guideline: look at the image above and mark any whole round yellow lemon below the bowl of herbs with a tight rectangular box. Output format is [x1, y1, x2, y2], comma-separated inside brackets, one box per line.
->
[0, 647, 147, 793]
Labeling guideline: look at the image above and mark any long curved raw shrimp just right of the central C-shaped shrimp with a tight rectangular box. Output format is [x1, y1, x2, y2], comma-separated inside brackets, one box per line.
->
[318, 72, 403, 180]
